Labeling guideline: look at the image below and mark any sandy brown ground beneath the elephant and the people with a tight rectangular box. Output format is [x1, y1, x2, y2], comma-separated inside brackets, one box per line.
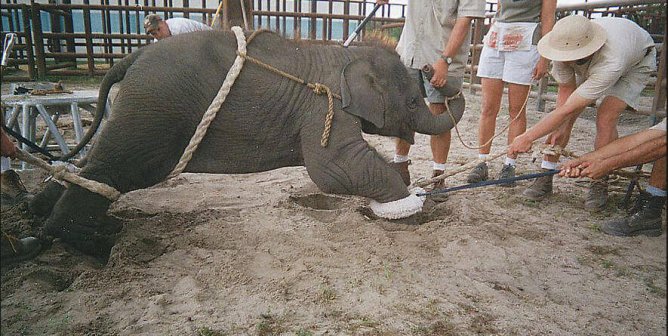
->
[1, 82, 666, 335]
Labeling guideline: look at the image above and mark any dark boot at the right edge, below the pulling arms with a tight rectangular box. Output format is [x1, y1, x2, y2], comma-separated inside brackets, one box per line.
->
[601, 192, 666, 237]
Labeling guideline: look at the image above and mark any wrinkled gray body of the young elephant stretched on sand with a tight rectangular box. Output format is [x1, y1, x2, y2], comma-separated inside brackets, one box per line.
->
[37, 31, 464, 257]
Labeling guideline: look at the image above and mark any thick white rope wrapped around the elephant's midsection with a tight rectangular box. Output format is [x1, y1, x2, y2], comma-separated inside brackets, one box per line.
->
[167, 26, 246, 179]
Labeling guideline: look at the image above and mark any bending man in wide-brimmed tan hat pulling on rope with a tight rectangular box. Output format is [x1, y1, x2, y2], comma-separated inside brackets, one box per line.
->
[508, 15, 656, 211]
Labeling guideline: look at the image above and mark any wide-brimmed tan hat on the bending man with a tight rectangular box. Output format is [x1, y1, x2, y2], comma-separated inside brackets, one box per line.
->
[538, 15, 608, 62]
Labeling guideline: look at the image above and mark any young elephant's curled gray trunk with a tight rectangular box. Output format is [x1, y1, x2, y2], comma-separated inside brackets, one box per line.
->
[411, 93, 466, 135]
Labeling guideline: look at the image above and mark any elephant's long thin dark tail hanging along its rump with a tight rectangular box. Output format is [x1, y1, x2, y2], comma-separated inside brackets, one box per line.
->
[55, 48, 143, 161]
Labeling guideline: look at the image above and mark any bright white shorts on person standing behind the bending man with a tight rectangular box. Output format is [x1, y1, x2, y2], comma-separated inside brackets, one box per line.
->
[477, 45, 540, 85]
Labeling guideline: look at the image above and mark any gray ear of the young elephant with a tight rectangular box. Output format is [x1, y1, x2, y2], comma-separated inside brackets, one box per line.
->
[341, 60, 385, 128]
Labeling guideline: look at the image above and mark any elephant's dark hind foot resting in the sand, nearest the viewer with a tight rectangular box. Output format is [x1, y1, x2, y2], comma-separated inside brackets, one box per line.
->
[45, 217, 122, 263]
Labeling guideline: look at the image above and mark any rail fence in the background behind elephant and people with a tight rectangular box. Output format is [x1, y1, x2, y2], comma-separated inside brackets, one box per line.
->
[0, 0, 666, 115]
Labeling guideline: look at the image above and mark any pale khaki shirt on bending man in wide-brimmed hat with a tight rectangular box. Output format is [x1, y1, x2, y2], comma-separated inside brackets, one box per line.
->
[551, 17, 654, 99]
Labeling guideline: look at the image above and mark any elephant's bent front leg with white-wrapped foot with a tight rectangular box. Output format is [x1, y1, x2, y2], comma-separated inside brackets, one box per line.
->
[304, 135, 424, 219]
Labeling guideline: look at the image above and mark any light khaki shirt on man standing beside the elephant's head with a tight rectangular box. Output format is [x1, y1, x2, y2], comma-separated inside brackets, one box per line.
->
[397, 0, 485, 77]
